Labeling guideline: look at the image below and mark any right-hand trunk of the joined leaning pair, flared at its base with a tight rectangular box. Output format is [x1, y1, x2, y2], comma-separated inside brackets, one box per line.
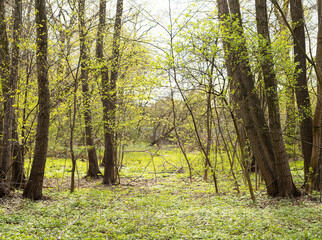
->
[255, 0, 300, 197]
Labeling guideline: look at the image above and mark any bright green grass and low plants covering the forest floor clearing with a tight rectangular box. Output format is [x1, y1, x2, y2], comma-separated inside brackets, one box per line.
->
[0, 145, 322, 239]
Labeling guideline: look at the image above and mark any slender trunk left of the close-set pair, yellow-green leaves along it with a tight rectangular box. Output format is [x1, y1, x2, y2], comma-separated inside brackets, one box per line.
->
[79, 0, 102, 178]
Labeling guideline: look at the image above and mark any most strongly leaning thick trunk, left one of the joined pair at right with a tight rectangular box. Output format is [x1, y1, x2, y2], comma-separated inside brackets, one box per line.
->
[220, 0, 278, 196]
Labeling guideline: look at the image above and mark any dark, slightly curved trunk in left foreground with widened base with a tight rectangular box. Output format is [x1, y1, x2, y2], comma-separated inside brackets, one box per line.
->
[23, 0, 50, 200]
